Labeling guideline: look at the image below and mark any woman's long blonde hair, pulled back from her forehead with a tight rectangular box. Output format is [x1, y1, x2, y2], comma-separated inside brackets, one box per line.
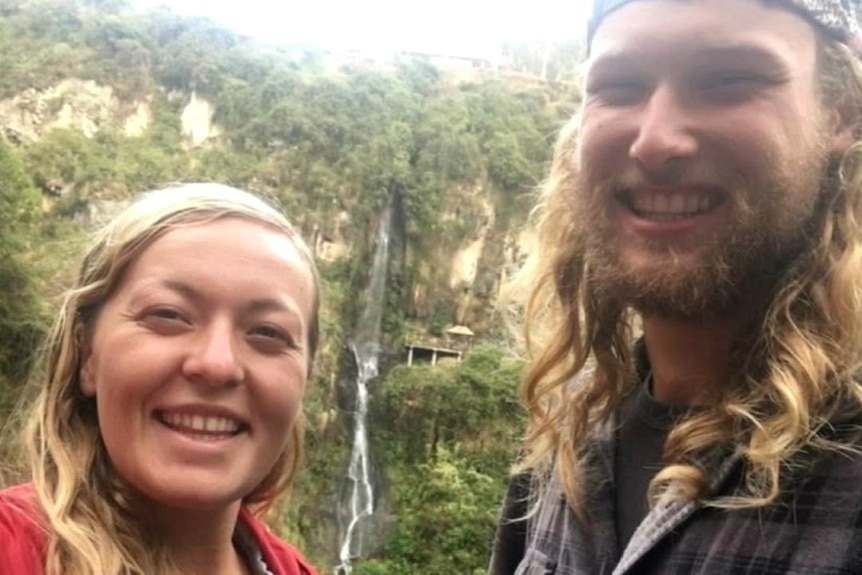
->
[25, 183, 319, 575]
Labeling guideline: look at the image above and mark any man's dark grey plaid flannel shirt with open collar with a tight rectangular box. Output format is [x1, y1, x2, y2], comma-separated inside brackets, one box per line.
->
[490, 416, 862, 575]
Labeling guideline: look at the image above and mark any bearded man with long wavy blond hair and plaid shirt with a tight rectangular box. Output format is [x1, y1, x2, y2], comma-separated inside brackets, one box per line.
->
[491, 0, 862, 575]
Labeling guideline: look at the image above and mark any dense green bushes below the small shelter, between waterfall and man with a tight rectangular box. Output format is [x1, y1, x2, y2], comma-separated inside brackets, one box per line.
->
[340, 346, 523, 575]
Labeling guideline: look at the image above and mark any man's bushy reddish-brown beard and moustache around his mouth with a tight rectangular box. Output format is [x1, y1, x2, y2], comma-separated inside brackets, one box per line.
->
[575, 149, 831, 320]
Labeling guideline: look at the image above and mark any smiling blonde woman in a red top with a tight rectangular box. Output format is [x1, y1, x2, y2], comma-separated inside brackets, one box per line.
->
[0, 184, 319, 575]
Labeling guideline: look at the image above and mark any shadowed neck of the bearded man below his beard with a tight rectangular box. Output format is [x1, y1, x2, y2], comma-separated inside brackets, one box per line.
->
[643, 316, 752, 405]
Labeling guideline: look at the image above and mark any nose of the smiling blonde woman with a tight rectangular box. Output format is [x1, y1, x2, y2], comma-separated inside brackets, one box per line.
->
[183, 321, 245, 385]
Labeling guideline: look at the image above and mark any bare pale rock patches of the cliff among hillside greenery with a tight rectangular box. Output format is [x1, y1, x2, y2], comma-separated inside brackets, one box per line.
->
[0, 78, 548, 333]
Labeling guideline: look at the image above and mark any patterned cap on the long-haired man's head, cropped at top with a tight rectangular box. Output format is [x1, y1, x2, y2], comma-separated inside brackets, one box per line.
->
[588, 0, 862, 54]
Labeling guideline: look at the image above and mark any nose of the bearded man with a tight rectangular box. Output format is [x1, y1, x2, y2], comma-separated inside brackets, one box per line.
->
[629, 85, 698, 173]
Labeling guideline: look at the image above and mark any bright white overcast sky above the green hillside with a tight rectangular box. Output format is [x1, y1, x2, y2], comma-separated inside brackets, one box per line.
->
[137, 0, 591, 56]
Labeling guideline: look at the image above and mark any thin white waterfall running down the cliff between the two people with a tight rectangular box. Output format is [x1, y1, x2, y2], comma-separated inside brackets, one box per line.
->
[335, 197, 393, 575]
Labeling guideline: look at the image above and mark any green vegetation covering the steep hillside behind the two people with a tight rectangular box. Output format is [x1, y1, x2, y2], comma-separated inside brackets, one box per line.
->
[0, 0, 576, 575]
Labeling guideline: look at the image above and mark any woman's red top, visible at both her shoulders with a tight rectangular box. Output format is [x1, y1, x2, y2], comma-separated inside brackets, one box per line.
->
[0, 483, 318, 575]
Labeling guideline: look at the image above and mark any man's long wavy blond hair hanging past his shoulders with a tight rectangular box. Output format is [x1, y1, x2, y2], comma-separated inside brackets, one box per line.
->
[515, 39, 862, 513]
